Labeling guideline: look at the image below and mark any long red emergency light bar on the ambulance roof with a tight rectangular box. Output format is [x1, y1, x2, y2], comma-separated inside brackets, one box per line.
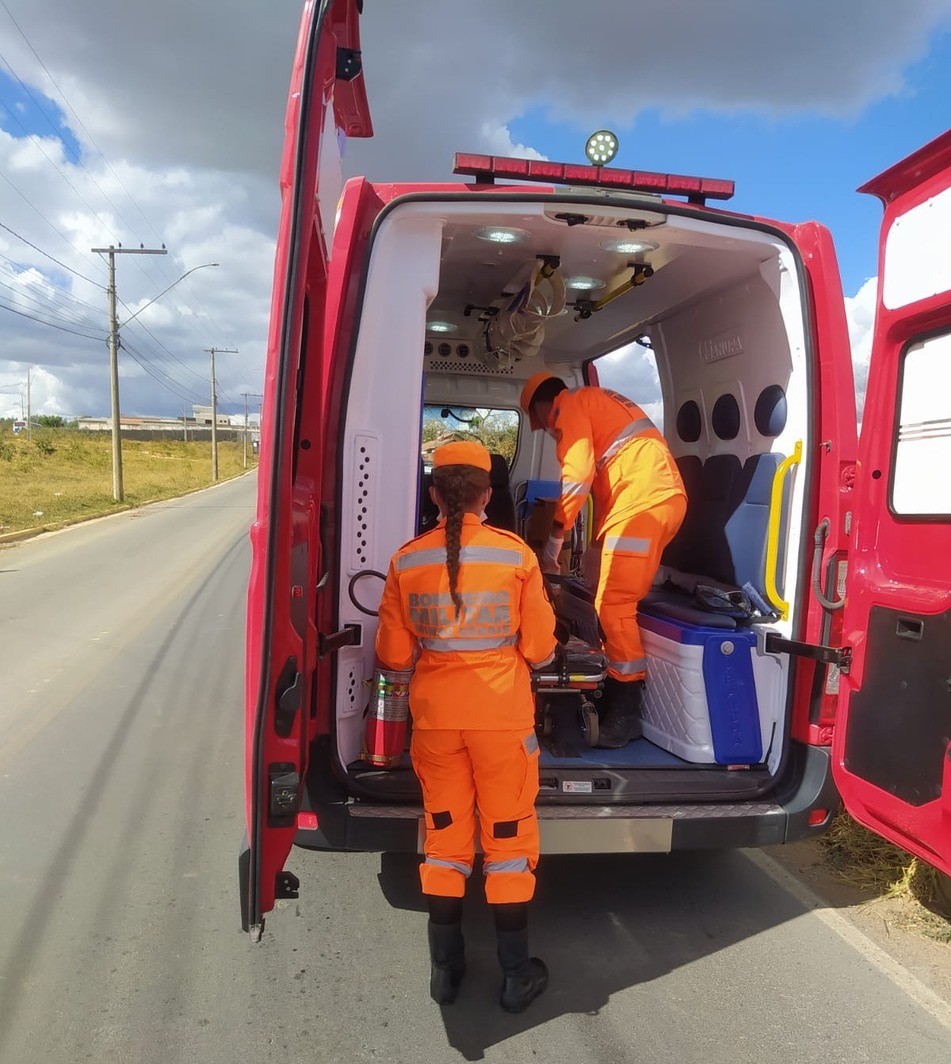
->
[452, 151, 736, 204]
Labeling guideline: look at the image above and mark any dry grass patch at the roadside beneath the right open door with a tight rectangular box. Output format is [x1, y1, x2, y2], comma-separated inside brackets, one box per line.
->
[819, 811, 951, 943]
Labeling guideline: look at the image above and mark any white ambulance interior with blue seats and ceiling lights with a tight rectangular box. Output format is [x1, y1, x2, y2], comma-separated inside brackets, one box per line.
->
[336, 195, 810, 803]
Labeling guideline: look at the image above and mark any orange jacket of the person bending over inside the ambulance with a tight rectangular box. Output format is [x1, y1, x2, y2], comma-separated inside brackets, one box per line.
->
[552, 387, 686, 535]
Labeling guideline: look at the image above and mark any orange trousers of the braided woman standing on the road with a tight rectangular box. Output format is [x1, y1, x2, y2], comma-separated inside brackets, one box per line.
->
[410, 729, 538, 904]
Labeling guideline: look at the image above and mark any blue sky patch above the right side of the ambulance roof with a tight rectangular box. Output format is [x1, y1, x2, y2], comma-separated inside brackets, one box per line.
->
[508, 32, 951, 295]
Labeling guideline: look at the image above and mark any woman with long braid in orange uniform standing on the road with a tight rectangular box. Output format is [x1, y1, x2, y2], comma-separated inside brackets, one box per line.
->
[377, 442, 557, 1012]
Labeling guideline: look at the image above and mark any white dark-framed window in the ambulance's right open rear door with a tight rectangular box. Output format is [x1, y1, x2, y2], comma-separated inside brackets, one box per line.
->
[891, 333, 951, 517]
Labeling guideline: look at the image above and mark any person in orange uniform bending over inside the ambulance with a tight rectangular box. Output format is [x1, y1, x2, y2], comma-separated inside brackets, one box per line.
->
[520, 372, 687, 748]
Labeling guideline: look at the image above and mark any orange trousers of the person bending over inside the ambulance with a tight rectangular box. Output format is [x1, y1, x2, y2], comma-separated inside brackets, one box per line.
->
[595, 495, 687, 682]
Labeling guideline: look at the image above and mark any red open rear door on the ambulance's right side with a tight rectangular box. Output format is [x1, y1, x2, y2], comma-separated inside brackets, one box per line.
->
[833, 131, 951, 874]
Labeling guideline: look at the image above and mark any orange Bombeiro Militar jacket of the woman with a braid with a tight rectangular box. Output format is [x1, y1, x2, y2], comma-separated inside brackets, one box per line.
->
[377, 514, 555, 731]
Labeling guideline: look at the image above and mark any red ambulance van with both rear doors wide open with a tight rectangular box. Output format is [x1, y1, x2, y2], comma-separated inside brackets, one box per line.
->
[239, 0, 951, 938]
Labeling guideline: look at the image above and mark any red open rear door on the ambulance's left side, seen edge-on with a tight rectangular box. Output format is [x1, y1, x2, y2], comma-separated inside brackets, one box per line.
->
[238, 0, 372, 938]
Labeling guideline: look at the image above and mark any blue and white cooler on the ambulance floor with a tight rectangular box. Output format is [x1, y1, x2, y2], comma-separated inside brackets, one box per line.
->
[637, 612, 773, 765]
